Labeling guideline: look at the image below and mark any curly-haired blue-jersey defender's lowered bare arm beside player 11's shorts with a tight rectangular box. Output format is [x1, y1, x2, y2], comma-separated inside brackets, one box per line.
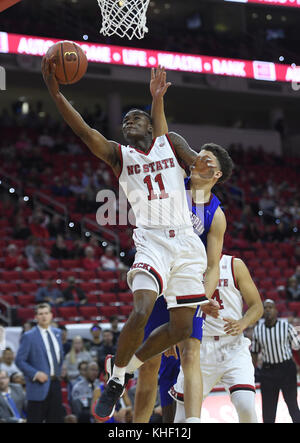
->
[204, 207, 226, 298]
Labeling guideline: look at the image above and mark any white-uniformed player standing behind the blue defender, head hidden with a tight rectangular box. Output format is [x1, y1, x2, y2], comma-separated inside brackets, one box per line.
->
[169, 255, 263, 423]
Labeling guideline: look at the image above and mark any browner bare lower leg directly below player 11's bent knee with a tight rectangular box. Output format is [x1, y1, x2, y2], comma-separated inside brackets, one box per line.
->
[133, 355, 161, 423]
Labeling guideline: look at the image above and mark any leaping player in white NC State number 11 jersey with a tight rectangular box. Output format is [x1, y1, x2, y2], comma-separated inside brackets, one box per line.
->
[42, 57, 219, 421]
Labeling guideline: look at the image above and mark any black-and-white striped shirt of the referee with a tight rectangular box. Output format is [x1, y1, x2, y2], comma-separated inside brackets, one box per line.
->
[251, 319, 300, 364]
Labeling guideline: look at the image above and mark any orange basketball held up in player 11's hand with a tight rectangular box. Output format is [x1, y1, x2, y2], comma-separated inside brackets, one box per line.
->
[46, 40, 88, 85]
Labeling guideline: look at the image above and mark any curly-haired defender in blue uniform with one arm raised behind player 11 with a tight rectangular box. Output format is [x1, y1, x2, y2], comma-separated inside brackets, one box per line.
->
[134, 68, 233, 423]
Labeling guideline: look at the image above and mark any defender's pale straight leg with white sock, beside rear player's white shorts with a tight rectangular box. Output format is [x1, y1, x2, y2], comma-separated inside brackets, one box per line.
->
[179, 338, 203, 423]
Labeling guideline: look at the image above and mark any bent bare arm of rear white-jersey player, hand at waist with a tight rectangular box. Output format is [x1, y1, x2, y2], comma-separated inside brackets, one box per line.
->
[224, 258, 264, 335]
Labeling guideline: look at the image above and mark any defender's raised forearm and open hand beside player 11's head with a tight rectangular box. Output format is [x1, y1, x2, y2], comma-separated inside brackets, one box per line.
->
[150, 66, 171, 138]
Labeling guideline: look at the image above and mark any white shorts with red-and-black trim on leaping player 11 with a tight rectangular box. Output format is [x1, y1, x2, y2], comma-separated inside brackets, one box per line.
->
[127, 227, 208, 309]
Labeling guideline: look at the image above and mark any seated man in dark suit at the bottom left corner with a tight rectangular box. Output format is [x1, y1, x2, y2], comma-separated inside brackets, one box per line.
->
[0, 371, 26, 423]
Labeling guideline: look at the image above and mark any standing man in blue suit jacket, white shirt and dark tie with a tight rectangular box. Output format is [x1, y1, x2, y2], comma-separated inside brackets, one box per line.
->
[16, 303, 64, 423]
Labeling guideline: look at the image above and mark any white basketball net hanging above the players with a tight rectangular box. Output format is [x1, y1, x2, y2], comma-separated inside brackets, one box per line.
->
[98, 0, 150, 40]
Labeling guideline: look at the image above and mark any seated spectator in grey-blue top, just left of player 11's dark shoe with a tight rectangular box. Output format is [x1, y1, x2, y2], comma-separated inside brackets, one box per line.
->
[71, 362, 99, 423]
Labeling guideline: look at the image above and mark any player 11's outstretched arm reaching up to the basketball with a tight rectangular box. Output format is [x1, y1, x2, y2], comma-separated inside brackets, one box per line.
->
[42, 57, 121, 175]
